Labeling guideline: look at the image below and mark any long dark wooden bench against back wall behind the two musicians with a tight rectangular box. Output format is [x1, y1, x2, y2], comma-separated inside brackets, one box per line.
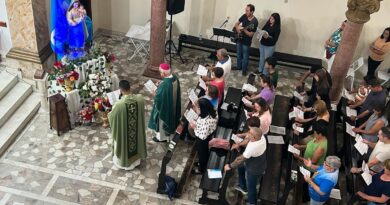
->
[178, 34, 322, 69]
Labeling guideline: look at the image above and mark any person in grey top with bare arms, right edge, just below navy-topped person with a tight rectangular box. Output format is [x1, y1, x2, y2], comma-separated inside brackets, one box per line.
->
[352, 104, 388, 142]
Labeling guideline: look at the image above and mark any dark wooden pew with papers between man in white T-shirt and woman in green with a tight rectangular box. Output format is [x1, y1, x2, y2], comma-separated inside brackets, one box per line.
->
[259, 95, 291, 204]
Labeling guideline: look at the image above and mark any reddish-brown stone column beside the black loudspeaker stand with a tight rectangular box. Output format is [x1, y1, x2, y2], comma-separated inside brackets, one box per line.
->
[144, 0, 167, 78]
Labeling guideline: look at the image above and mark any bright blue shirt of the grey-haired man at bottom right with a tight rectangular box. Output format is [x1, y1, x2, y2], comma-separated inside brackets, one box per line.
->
[309, 166, 339, 202]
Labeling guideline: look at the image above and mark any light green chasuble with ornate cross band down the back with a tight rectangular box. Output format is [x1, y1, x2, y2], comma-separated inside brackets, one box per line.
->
[108, 95, 146, 168]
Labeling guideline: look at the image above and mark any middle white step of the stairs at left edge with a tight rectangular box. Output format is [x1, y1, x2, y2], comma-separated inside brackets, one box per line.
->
[0, 82, 32, 128]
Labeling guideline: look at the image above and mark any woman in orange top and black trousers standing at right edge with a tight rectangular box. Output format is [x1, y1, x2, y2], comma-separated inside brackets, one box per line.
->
[367, 27, 390, 76]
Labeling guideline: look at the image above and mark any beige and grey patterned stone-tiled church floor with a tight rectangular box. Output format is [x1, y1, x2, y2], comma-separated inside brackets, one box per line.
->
[0, 29, 308, 205]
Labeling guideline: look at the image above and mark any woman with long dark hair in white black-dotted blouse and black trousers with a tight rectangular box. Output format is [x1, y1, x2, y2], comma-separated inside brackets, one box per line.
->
[189, 98, 218, 175]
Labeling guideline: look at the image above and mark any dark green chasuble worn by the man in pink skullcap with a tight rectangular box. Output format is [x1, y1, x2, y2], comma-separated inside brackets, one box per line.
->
[148, 75, 181, 134]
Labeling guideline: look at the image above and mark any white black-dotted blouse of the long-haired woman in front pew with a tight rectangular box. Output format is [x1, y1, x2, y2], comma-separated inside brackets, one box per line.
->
[194, 115, 218, 140]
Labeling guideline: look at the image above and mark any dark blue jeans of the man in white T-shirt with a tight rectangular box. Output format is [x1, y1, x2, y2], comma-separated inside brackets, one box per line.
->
[237, 166, 262, 204]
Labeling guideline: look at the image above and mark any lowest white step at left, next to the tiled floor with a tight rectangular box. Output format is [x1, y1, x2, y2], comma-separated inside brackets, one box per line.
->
[0, 94, 41, 156]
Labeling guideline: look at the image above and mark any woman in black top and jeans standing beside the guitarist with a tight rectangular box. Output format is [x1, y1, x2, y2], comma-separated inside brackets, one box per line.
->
[258, 13, 280, 75]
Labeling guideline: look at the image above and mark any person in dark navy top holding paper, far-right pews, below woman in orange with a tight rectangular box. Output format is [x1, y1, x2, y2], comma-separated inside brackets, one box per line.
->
[349, 78, 387, 125]
